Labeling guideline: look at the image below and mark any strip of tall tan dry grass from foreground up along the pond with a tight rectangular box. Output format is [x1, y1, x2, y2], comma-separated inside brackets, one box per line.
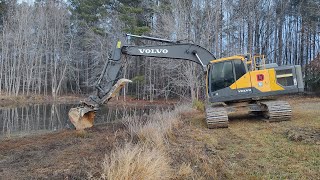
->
[101, 105, 193, 180]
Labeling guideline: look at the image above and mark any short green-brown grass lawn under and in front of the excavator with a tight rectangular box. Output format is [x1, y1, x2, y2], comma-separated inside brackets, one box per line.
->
[174, 99, 320, 179]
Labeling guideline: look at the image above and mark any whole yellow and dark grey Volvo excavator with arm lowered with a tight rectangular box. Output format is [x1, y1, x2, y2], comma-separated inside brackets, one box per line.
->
[68, 34, 304, 130]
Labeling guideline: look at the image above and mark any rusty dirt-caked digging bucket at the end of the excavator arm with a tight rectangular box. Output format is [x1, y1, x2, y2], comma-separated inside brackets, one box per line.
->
[68, 107, 96, 130]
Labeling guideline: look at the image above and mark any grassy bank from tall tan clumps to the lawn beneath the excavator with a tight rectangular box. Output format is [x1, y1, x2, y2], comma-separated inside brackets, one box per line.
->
[96, 99, 320, 179]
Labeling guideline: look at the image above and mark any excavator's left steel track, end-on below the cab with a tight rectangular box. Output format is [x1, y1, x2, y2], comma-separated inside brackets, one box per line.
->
[206, 106, 229, 129]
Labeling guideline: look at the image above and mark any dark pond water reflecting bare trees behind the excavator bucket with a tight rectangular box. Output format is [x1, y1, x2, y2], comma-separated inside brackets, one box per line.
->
[0, 104, 168, 139]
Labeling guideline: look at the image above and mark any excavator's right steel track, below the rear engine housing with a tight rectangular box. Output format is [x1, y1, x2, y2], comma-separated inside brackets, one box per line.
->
[261, 101, 292, 122]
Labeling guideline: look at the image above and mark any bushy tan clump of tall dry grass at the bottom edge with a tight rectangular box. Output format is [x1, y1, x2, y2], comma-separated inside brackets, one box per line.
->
[101, 143, 171, 180]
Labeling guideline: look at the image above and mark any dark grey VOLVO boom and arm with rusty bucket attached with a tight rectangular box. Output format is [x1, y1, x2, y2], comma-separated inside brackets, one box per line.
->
[68, 34, 215, 130]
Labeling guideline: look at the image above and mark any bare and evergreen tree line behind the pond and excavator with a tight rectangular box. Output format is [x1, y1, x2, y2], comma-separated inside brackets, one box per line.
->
[0, 0, 320, 100]
